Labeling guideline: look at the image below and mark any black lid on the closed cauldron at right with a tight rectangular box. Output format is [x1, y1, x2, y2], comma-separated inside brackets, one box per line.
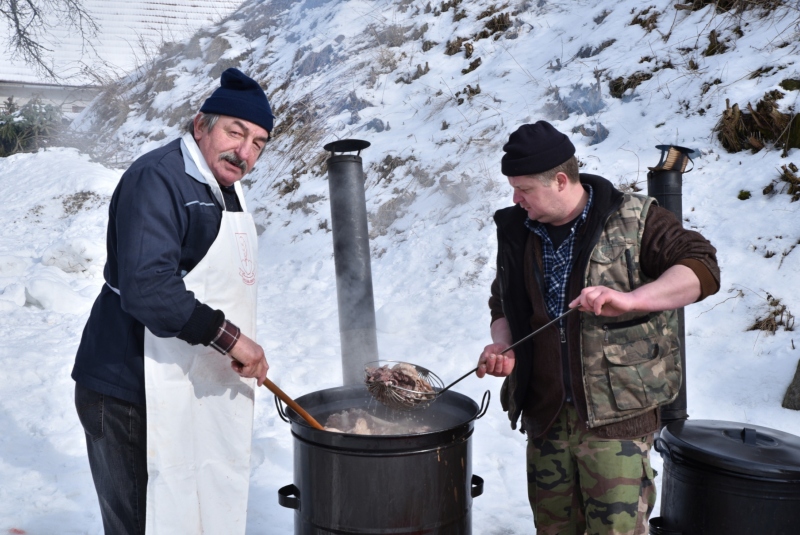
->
[656, 420, 800, 481]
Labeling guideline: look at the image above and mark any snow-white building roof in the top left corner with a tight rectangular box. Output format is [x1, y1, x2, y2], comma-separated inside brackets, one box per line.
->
[0, 0, 242, 85]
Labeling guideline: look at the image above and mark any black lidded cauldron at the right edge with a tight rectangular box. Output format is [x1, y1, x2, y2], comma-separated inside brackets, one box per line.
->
[650, 420, 800, 535]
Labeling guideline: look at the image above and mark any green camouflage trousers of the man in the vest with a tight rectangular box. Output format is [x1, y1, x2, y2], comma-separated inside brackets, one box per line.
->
[527, 404, 656, 535]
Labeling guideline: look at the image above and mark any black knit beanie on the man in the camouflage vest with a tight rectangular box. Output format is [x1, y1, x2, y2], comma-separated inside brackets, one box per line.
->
[500, 121, 575, 176]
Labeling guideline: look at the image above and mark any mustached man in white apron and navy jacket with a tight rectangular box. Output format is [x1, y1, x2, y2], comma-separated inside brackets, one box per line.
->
[72, 69, 273, 535]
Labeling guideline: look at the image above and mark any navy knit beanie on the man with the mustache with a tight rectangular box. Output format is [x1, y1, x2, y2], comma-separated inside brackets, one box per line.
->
[200, 68, 274, 132]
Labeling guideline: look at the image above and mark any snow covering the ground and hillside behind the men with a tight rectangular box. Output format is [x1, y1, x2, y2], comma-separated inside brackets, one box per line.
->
[0, 0, 800, 535]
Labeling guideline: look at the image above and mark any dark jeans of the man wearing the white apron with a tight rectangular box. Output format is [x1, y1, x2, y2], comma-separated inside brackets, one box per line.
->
[75, 384, 147, 535]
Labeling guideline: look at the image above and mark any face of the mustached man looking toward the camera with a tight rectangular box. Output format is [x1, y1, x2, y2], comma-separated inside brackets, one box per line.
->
[194, 115, 269, 186]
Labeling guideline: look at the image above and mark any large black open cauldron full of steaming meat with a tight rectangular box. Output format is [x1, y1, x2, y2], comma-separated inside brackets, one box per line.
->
[278, 385, 489, 535]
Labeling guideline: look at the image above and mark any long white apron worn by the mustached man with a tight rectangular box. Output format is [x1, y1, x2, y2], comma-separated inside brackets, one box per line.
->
[144, 135, 257, 535]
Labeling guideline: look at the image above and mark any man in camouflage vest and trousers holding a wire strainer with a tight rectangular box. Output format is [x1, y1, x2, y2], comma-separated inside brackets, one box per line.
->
[477, 121, 720, 535]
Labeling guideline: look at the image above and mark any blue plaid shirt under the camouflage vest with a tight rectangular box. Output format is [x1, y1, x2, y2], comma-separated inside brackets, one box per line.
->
[525, 184, 594, 318]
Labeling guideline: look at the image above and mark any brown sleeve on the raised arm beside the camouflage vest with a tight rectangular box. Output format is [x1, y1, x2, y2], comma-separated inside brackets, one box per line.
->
[640, 206, 720, 301]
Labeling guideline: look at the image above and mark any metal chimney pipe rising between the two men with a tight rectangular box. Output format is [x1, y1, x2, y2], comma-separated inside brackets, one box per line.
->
[324, 139, 378, 386]
